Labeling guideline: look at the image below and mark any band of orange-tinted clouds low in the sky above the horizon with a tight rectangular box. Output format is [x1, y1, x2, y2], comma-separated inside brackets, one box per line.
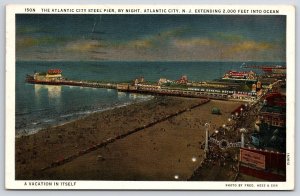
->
[16, 28, 285, 61]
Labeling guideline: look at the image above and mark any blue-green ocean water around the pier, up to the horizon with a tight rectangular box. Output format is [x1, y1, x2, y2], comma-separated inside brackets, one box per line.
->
[15, 61, 285, 135]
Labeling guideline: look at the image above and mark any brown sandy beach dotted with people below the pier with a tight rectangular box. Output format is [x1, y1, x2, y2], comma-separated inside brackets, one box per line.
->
[16, 97, 241, 180]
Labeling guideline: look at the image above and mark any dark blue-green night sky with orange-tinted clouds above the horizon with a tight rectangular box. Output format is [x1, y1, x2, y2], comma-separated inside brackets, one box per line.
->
[16, 14, 286, 61]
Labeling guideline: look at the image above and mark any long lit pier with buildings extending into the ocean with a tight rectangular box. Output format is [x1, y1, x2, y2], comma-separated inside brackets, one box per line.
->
[26, 69, 282, 102]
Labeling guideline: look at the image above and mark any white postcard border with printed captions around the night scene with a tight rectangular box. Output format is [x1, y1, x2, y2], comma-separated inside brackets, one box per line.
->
[5, 4, 295, 190]
